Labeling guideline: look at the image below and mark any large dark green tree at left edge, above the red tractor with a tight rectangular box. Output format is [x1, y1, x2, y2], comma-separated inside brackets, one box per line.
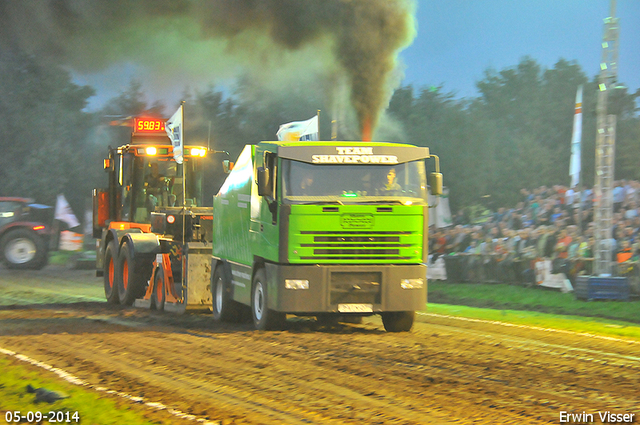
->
[0, 49, 95, 210]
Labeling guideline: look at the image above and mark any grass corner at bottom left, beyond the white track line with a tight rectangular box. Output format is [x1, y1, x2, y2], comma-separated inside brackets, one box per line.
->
[0, 355, 185, 425]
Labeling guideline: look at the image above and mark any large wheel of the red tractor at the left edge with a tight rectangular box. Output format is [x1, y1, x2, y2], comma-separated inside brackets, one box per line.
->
[0, 229, 47, 270]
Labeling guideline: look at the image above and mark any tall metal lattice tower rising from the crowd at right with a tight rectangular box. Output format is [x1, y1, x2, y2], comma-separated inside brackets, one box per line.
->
[593, 0, 619, 276]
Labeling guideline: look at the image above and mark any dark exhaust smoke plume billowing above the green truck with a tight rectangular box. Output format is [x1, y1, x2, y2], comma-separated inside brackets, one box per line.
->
[0, 0, 415, 135]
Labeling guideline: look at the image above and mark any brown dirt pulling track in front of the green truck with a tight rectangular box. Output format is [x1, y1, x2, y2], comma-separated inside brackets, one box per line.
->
[0, 267, 640, 424]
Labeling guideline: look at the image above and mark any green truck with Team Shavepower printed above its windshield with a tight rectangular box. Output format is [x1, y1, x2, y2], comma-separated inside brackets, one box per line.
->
[211, 141, 442, 332]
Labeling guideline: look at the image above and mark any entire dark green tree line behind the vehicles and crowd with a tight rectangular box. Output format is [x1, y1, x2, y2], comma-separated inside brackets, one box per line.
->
[0, 50, 640, 219]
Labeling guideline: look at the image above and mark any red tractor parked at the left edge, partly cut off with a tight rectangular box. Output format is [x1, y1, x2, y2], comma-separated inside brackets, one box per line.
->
[0, 197, 53, 269]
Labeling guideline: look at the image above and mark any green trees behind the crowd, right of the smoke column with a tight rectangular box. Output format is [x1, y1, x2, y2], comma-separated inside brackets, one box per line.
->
[388, 57, 640, 210]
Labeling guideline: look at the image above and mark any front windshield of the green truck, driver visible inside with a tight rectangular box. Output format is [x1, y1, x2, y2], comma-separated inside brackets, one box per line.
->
[281, 159, 427, 205]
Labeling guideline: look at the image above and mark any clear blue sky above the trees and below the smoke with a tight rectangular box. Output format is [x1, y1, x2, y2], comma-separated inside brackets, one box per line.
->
[75, 0, 640, 109]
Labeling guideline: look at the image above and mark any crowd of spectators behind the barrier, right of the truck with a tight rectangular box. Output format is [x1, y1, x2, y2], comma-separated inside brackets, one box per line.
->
[429, 180, 640, 285]
